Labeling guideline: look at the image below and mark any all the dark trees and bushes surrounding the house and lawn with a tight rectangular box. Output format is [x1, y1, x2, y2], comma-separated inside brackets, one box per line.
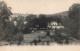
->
[0, 1, 80, 44]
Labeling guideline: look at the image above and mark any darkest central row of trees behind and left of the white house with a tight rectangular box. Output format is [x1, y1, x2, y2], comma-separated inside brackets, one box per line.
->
[26, 14, 61, 28]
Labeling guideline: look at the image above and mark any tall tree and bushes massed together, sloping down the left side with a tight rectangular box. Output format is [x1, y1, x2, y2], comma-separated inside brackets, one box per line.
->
[0, 1, 23, 41]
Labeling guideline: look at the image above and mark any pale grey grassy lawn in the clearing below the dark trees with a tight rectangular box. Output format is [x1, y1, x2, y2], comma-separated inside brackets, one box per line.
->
[24, 31, 46, 42]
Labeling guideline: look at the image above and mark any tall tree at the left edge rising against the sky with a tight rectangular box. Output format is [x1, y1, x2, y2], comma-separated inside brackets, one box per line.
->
[0, 1, 12, 40]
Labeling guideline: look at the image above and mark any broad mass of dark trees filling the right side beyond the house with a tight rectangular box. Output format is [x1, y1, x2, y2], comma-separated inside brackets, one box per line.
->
[61, 4, 80, 40]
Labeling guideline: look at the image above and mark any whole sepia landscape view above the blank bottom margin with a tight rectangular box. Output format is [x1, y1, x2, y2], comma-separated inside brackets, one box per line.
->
[0, 0, 80, 46]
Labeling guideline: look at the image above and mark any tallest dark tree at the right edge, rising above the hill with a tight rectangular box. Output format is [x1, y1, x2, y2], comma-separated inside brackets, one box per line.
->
[68, 4, 80, 39]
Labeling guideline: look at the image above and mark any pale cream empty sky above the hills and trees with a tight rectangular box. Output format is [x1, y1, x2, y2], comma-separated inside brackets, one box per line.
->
[1, 0, 80, 14]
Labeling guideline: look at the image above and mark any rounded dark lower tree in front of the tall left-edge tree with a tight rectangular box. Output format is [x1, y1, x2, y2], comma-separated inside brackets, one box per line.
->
[3, 22, 19, 41]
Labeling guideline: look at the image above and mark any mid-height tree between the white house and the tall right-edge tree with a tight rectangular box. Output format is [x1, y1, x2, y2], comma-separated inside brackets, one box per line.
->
[61, 16, 72, 35]
